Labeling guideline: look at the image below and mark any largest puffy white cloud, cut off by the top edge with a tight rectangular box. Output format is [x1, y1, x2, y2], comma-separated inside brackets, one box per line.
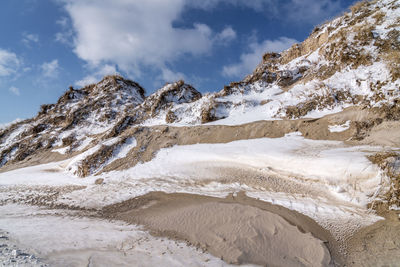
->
[60, 0, 234, 82]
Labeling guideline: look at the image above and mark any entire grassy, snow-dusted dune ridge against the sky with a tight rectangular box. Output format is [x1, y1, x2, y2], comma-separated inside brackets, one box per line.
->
[0, 0, 400, 171]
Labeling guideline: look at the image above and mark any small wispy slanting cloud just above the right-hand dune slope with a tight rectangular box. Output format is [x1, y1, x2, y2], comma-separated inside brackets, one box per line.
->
[222, 37, 297, 78]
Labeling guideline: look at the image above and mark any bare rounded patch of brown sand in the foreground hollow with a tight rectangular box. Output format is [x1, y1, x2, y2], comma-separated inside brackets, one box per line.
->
[103, 192, 341, 266]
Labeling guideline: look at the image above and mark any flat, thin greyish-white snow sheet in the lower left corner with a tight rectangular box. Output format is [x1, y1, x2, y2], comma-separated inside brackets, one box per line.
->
[0, 205, 250, 267]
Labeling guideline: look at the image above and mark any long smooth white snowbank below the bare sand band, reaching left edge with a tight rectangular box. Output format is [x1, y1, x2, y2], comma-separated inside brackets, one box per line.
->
[0, 133, 386, 226]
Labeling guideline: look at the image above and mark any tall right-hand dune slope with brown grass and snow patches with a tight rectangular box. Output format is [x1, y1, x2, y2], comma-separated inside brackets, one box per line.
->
[147, 0, 400, 125]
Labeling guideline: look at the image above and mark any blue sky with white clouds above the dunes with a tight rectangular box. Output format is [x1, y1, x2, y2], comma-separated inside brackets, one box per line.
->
[0, 0, 355, 125]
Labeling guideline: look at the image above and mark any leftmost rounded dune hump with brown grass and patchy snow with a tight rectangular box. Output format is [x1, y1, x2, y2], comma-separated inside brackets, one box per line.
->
[0, 76, 145, 167]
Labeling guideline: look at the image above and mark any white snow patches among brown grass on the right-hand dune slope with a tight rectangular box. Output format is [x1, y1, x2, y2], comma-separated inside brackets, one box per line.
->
[135, 0, 400, 129]
